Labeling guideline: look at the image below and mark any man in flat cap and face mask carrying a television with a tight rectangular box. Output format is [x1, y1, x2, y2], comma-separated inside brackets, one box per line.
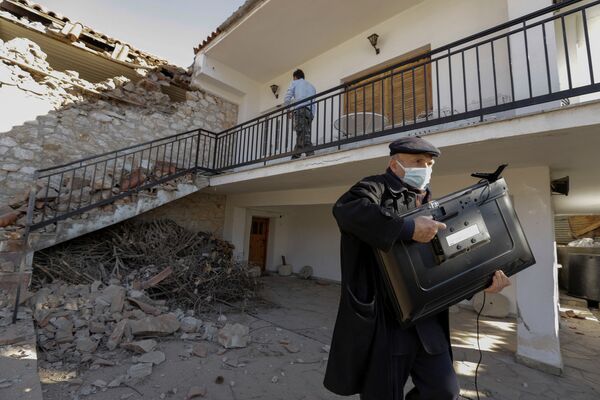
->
[324, 137, 510, 400]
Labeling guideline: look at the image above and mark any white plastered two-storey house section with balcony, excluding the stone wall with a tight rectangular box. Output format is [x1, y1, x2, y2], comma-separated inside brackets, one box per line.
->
[192, 0, 600, 373]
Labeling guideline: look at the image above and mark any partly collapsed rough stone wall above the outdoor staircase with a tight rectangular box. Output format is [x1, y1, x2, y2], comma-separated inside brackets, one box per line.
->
[0, 38, 237, 205]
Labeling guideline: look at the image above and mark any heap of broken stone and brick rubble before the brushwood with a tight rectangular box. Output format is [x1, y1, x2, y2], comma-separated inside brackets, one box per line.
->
[29, 276, 250, 364]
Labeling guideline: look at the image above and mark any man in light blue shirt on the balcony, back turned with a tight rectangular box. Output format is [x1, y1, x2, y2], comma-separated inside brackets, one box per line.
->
[283, 69, 317, 160]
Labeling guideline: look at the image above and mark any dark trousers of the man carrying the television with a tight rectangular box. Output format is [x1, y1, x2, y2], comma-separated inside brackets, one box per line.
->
[360, 330, 460, 400]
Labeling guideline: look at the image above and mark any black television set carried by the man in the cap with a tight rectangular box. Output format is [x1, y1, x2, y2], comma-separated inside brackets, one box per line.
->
[375, 165, 535, 327]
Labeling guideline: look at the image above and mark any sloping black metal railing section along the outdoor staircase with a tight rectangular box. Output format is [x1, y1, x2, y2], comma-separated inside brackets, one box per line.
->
[29, 129, 216, 229]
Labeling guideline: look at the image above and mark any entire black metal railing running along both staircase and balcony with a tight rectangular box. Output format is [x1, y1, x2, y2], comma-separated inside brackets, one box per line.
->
[28, 0, 600, 229]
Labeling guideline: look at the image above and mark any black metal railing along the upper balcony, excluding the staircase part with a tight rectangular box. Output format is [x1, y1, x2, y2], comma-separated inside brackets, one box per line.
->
[215, 0, 600, 171]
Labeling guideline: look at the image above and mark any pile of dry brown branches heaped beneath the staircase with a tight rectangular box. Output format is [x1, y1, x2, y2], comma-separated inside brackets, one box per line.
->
[33, 220, 260, 314]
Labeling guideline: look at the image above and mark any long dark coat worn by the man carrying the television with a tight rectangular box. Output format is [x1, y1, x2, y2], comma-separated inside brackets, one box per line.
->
[324, 169, 450, 400]
